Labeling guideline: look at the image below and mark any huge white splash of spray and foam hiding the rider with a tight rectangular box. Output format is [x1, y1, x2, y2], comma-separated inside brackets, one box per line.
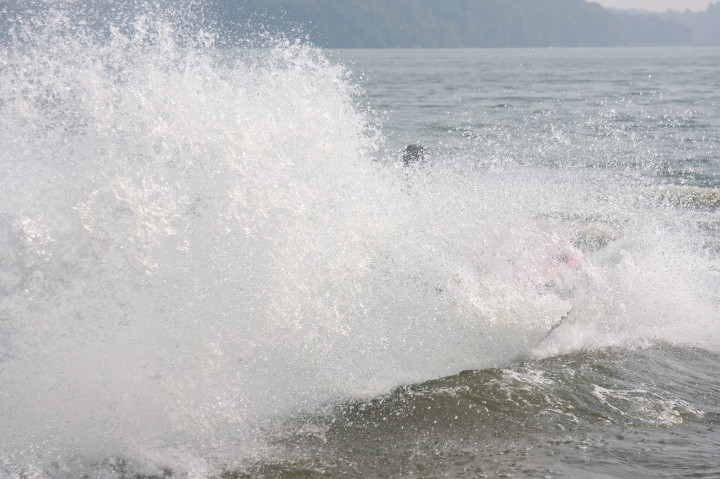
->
[0, 4, 718, 477]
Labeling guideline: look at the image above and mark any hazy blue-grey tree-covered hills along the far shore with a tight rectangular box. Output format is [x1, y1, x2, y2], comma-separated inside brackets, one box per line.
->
[0, 0, 720, 48]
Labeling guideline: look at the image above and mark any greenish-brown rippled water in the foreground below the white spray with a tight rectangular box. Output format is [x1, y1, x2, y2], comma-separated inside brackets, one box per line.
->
[247, 344, 720, 478]
